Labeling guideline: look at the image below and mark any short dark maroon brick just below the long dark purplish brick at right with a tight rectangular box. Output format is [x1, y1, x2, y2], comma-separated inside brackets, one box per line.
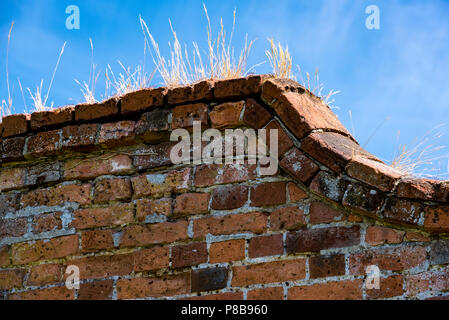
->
[309, 254, 346, 279]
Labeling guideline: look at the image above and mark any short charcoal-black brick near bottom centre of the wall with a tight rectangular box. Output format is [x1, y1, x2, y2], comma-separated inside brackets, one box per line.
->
[191, 267, 228, 292]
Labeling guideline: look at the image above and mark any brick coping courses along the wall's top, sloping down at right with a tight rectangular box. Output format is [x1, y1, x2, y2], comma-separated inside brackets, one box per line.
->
[0, 75, 449, 233]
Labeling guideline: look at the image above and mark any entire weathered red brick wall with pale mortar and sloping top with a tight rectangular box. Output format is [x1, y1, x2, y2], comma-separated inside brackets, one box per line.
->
[0, 76, 449, 299]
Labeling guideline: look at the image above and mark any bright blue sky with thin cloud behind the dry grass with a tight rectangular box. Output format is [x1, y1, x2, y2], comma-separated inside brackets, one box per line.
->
[0, 0, 449, 173]
